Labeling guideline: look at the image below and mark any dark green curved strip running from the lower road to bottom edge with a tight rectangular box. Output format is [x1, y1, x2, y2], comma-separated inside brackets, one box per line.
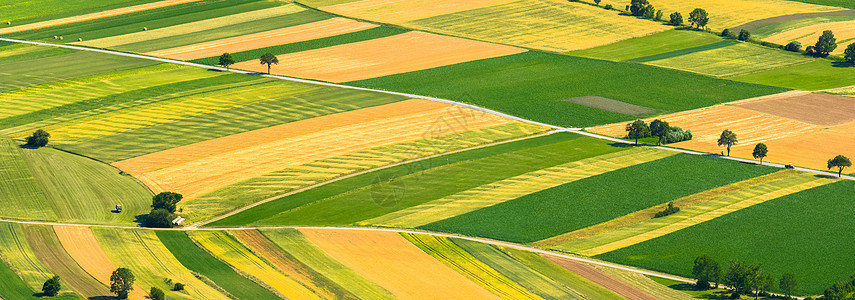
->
[157, 231, 279, 299]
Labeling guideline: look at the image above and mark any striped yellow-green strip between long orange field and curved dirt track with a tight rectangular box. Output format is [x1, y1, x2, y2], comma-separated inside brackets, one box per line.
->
[204, 122, 546, 225]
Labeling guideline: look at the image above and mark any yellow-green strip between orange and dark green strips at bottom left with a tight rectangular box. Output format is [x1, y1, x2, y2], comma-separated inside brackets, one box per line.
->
[91, 227, 228, 299]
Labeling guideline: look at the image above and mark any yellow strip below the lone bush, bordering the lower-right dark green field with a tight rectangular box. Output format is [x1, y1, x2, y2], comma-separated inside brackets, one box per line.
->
[552, 172, 833, 256]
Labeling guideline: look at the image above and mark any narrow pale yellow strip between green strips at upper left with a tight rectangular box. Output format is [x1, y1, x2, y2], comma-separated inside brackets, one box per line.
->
[74, 4, 305, 48]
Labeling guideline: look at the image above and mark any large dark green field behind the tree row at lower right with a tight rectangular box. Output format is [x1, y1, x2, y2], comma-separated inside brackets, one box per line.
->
[598, 181, 855, 295]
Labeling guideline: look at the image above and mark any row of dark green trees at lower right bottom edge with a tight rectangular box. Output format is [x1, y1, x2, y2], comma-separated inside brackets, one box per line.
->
[692, 255, 798, 299]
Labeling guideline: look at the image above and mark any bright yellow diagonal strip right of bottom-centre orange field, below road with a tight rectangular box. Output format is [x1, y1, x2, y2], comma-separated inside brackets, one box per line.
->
[401, 233, 540, 299]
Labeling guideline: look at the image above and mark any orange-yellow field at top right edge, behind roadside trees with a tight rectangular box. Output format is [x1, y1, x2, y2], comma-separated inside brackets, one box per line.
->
[763, 21, 855, 54]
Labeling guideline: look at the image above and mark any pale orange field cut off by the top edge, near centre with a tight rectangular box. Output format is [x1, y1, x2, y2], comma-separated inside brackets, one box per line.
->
[320, 0, 514, 23]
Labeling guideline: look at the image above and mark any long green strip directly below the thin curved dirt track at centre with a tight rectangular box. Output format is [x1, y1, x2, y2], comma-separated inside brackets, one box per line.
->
[234, 134, 626, 226]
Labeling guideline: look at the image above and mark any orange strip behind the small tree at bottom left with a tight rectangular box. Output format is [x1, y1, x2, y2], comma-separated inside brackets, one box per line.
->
[53, 225, 146, 299]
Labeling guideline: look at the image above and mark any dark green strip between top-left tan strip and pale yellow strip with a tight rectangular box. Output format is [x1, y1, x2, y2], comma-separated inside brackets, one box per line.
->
[5, 0, 281, 44]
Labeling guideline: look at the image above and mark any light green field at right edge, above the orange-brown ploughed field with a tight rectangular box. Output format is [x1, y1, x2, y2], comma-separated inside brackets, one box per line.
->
[730, 59, 855, 91]
